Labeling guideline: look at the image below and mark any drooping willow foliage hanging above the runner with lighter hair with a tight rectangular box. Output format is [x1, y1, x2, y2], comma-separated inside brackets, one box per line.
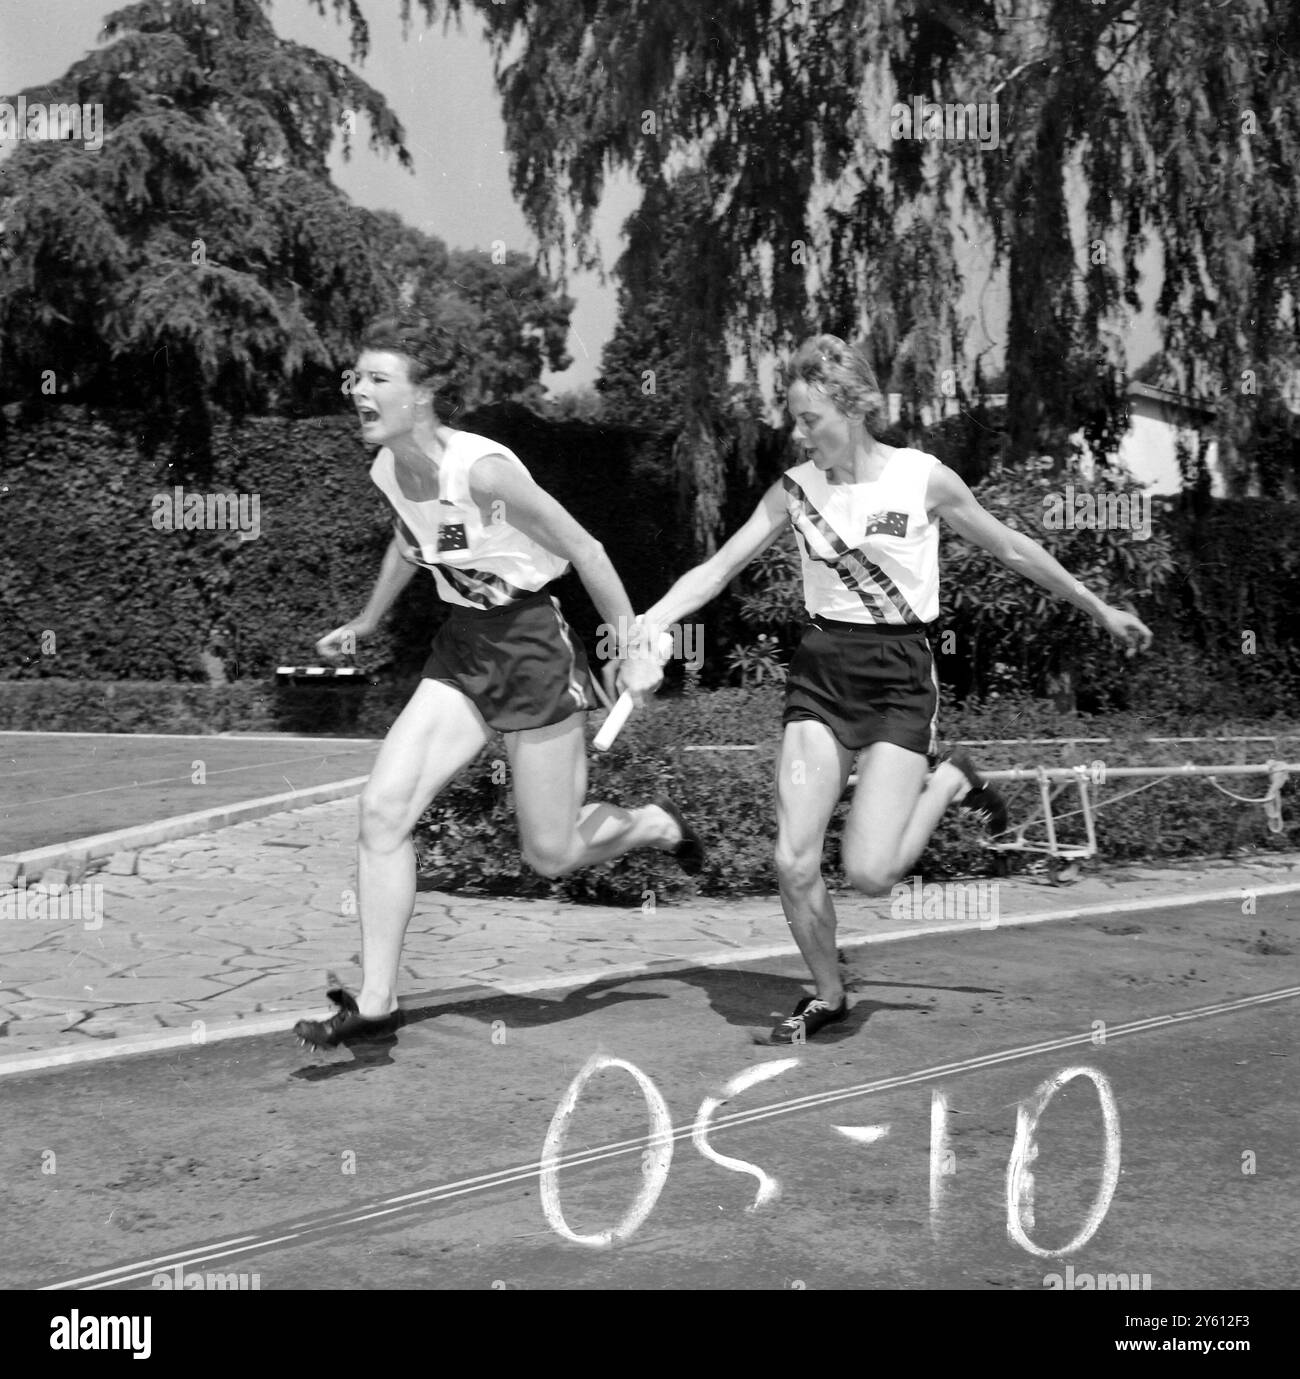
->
[343, 0, 1300, 543]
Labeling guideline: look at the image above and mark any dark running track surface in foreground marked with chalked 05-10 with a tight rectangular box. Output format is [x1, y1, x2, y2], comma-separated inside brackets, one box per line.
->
[0, 895, 1300, 1290]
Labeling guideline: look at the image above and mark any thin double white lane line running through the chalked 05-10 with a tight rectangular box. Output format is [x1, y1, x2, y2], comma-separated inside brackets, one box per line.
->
[43, 986, 1300, 1292]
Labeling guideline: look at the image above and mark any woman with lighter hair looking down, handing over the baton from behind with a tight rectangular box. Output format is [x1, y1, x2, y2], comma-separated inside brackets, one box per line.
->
[638, 335, 1151, 1044]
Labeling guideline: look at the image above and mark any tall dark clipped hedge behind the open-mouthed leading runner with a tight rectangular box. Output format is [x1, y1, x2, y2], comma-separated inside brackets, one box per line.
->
[0, 404, 689, 683]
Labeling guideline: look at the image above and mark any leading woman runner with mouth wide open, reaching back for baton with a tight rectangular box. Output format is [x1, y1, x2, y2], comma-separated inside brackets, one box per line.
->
[294, 319, 703, 1048]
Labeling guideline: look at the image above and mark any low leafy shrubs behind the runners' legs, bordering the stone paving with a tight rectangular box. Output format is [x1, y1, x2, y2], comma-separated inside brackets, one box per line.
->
[416, 690, 1300, 906]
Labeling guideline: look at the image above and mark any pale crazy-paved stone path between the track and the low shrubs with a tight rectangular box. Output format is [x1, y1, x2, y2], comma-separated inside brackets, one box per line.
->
[0, 800, 1300, 1070]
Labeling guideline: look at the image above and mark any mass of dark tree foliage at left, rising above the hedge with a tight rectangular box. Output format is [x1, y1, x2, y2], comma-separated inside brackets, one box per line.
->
[0, 0, 572, 435]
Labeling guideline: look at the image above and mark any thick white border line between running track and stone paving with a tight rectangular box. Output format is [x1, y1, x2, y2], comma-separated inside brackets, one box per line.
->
[0, 882, 1300, 1077]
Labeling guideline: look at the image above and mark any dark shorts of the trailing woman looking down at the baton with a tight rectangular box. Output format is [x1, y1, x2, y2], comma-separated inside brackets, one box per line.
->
[782, 618, 939, 756]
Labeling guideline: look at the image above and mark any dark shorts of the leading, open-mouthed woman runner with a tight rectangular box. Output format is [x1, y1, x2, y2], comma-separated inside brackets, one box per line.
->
[423, 589, 596, 732]
